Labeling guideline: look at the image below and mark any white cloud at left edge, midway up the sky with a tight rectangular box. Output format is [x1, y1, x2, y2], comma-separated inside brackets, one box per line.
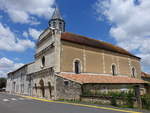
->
[0, 23, 34, 51]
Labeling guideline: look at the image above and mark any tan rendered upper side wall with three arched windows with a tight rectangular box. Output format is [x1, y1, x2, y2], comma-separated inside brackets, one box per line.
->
[61, 41, 141, 79]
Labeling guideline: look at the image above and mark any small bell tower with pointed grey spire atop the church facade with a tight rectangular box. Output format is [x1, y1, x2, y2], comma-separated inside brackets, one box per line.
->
[49, 7, 65, 32]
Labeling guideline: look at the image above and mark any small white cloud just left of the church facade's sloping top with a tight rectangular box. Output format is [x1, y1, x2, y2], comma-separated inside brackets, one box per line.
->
[28, 28, 42, 40]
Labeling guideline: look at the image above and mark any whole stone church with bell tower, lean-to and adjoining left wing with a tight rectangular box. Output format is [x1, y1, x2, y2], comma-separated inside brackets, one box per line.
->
[6, 8, 144, 99]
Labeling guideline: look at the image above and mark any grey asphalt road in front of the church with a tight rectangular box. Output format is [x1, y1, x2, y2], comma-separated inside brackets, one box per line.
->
[0, 93, 148, 113]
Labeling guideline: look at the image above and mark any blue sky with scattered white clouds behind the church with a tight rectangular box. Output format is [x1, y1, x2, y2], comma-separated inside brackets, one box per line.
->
[0, 0, 150, 76]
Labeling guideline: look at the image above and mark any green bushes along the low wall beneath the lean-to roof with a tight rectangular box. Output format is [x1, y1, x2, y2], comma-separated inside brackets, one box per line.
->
[81, 90, 137, 108]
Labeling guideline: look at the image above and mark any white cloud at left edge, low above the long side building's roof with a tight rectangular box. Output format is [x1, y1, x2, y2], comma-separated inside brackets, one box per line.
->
[0, 57, 24, 77]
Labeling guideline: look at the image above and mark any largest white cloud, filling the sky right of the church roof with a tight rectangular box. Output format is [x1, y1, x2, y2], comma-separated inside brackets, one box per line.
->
[96, 0, 150, 72]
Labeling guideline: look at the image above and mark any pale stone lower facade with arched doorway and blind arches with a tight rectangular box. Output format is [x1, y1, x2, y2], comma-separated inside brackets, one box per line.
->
[31, 69, 55, 99]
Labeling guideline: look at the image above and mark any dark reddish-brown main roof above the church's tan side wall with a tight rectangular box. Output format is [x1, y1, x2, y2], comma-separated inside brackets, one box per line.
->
[61, 32, 140, 59]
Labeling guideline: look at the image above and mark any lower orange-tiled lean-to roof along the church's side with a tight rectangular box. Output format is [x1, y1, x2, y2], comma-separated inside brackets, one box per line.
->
[58, 74, 145, 84]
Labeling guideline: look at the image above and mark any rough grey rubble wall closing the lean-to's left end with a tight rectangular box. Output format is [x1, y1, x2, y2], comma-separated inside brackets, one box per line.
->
[56, 77, 81, 99]
